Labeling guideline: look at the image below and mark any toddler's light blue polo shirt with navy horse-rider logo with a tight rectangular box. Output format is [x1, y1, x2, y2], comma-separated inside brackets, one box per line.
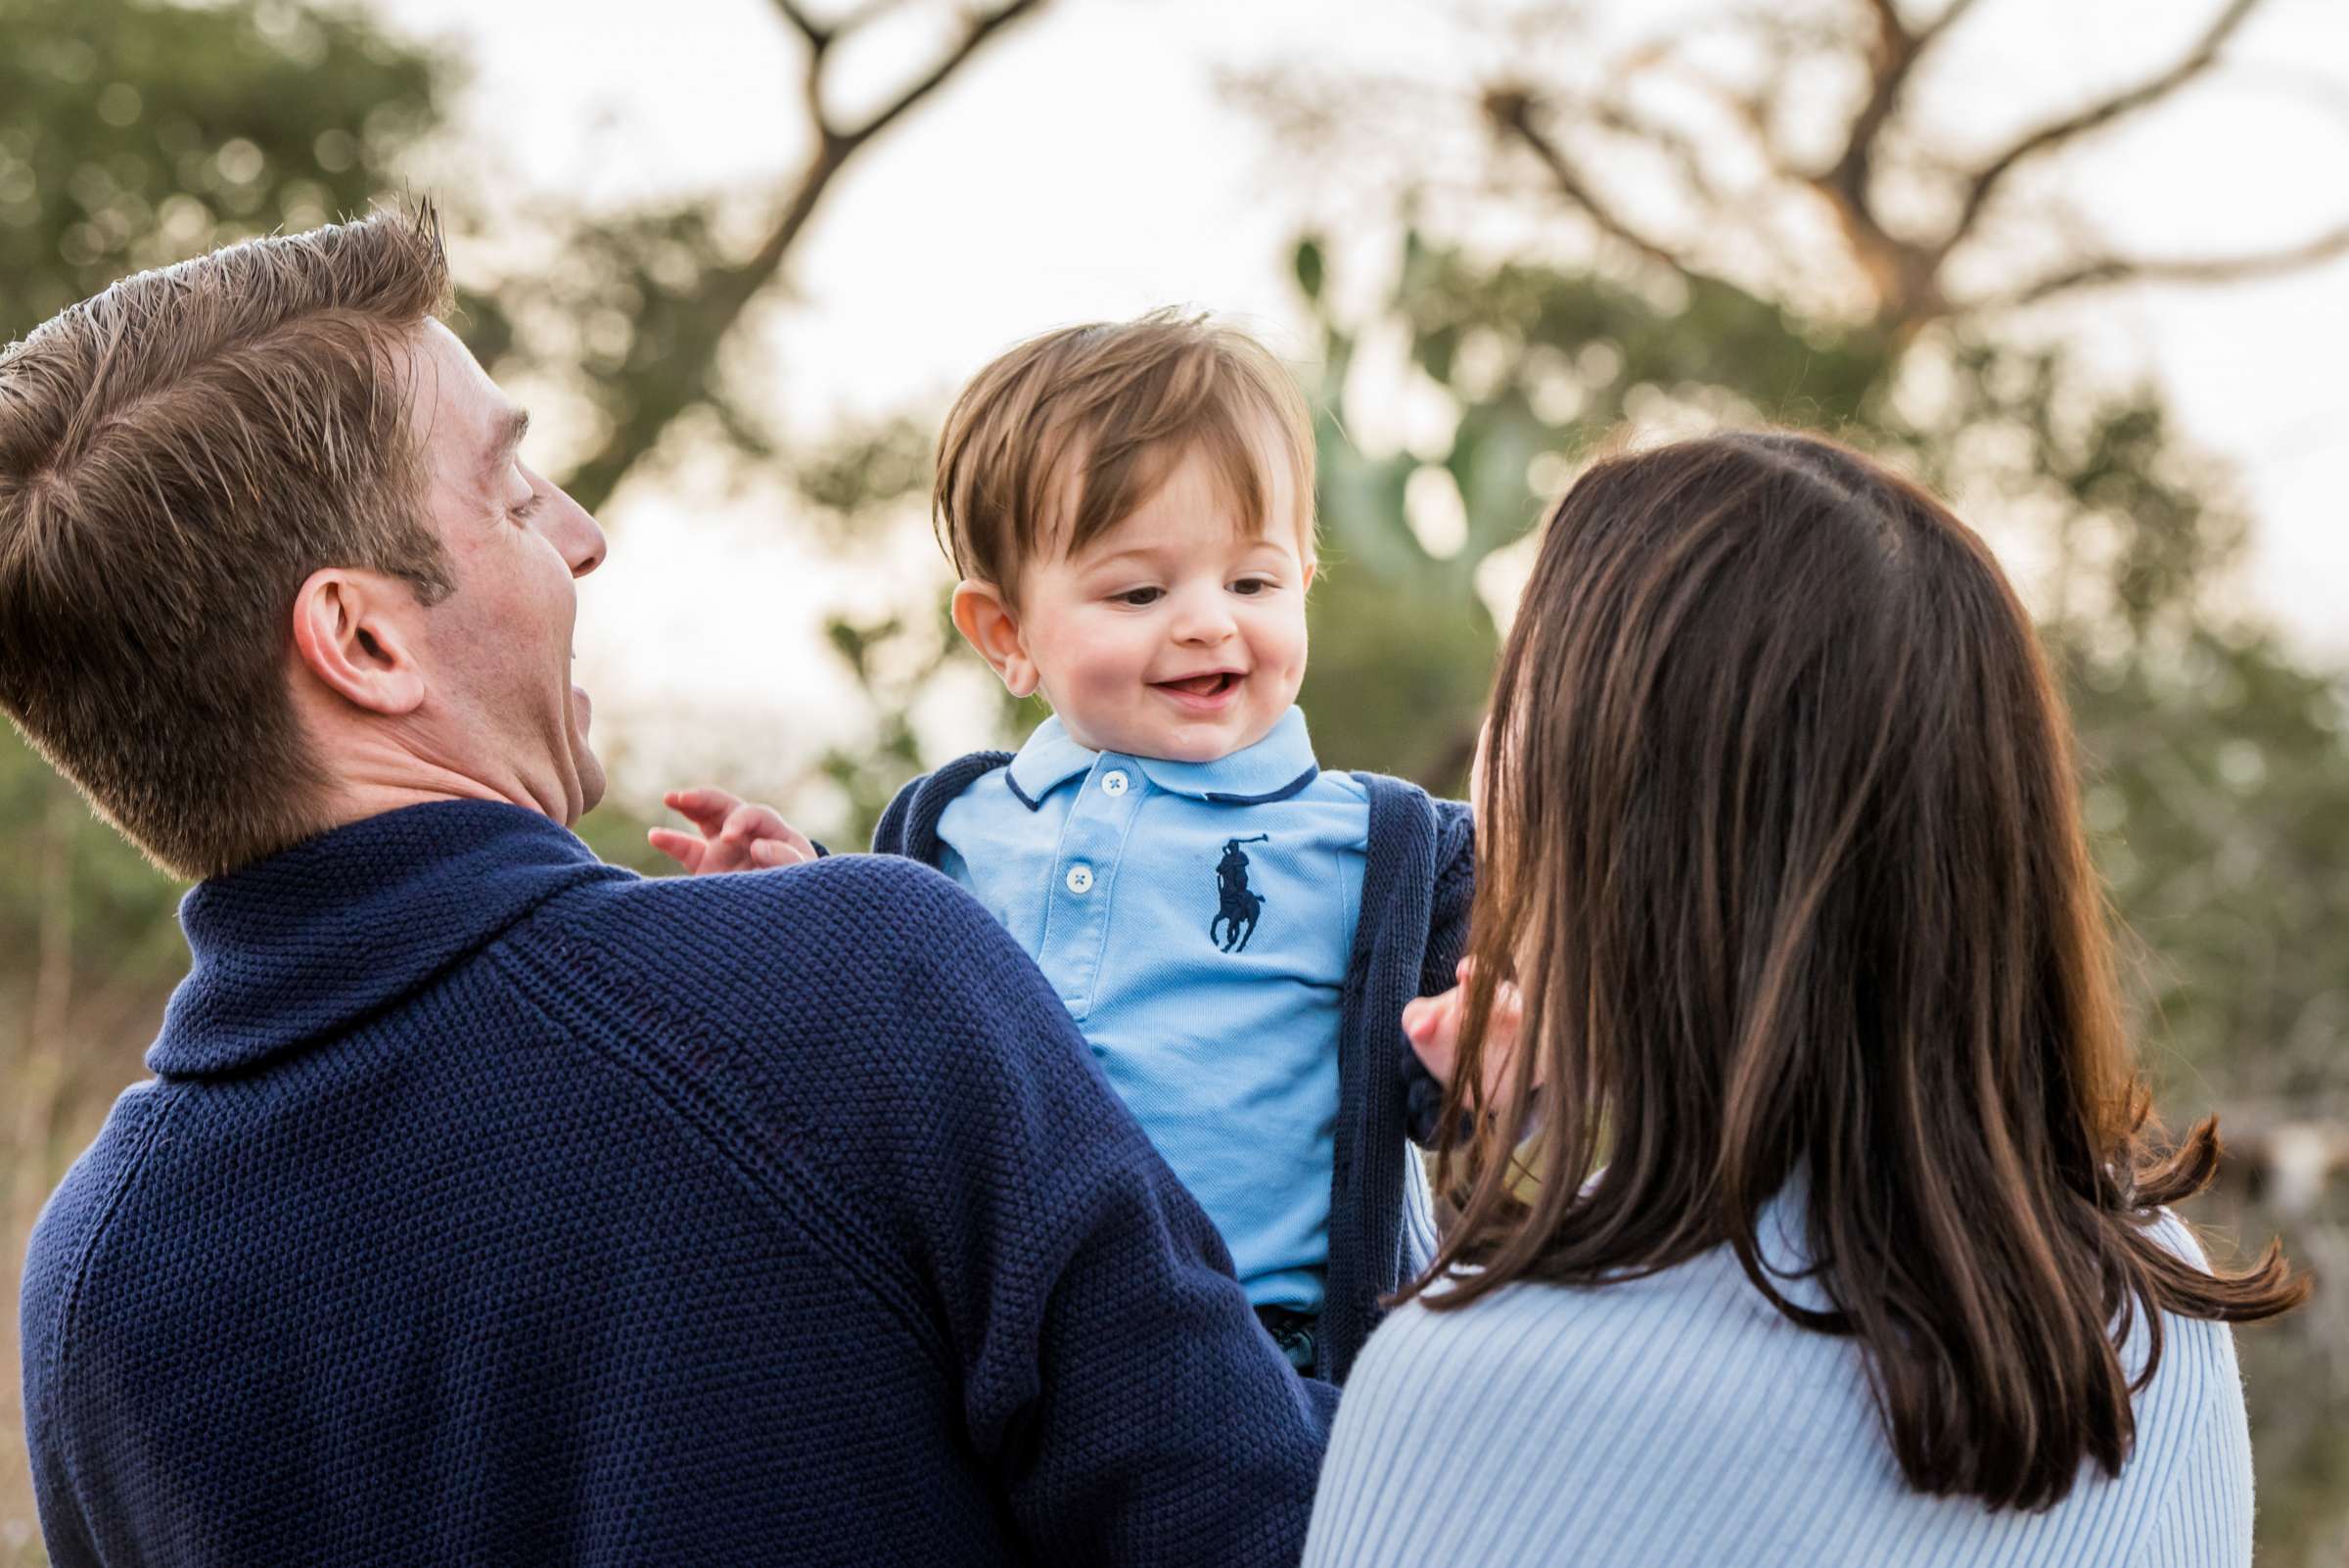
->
[938, 709, 1369, 1313]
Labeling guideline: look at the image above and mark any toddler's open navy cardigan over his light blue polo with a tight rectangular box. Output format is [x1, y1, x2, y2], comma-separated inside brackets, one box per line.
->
[874, 751, 1475, 1383]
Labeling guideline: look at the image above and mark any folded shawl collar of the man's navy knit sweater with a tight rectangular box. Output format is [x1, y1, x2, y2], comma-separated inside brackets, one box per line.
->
[146, 801, 632, 1078]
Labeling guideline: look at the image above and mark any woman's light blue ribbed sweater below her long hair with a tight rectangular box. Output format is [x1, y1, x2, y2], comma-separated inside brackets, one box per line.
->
[1306, 1195, 2250, 1568]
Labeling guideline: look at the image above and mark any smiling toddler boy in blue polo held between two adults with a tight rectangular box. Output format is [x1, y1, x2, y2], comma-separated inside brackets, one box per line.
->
[656, 312, 1473, 1380]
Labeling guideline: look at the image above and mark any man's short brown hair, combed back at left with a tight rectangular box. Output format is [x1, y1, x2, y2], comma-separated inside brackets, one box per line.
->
[0, 207, 451, 878]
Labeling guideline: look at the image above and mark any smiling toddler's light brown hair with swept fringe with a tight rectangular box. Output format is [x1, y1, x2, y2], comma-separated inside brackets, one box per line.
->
[930, 310, 1313, 601]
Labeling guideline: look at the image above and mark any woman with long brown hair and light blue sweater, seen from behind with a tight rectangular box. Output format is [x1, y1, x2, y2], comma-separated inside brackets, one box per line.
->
[1306, 435, 2307, 1568]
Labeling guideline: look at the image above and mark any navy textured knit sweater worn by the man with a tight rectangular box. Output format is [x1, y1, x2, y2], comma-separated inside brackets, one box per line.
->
[23, 803, 1332, 1568]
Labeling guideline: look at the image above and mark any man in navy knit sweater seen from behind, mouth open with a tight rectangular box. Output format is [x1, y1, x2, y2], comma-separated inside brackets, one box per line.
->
[0, 216, 1329, 1568]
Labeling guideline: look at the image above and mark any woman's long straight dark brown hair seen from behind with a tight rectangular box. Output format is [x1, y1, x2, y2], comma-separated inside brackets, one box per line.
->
[1409, 435, 2309, 1507]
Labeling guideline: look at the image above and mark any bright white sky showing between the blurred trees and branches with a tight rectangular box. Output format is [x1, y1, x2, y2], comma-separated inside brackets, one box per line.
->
[369, 0, 2349, 826]
